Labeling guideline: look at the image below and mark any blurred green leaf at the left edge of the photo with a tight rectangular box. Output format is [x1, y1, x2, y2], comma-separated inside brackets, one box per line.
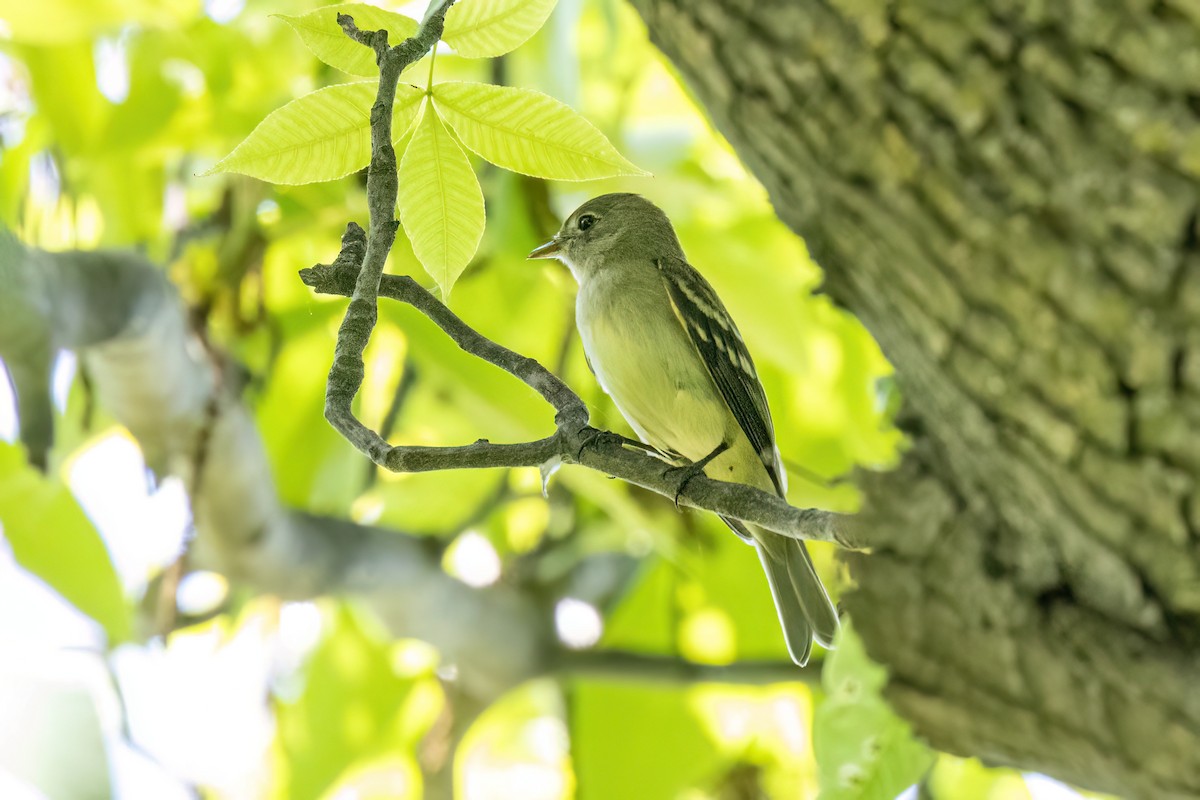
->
[0, 441, 132, 644]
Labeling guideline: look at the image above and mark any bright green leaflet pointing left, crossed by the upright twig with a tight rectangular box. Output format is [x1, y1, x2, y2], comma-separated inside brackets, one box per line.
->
[204, 80, 425, 185]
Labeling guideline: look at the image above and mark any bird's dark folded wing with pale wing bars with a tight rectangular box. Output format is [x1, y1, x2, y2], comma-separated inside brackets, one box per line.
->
[655, 258, 786, 497]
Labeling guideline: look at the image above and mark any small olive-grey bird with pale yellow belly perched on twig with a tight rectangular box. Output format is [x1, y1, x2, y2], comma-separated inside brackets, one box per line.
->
[528, 193, 839, 666]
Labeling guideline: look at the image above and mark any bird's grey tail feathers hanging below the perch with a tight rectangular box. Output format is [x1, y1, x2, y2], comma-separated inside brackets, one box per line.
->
[746, 525, 839, 667]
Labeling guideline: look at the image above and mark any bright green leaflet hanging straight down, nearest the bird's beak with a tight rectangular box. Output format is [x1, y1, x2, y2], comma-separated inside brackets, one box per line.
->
[397, 107, 485, 297]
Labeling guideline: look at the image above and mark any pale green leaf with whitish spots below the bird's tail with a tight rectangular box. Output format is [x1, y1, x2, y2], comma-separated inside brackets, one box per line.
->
[812, 622, 932, 800]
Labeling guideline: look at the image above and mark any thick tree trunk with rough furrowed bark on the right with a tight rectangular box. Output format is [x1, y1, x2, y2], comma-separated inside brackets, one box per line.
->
[635, 0, 1200, 798]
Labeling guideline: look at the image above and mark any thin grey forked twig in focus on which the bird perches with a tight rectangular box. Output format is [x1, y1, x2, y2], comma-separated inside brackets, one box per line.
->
[300, 0, 856, 546]
